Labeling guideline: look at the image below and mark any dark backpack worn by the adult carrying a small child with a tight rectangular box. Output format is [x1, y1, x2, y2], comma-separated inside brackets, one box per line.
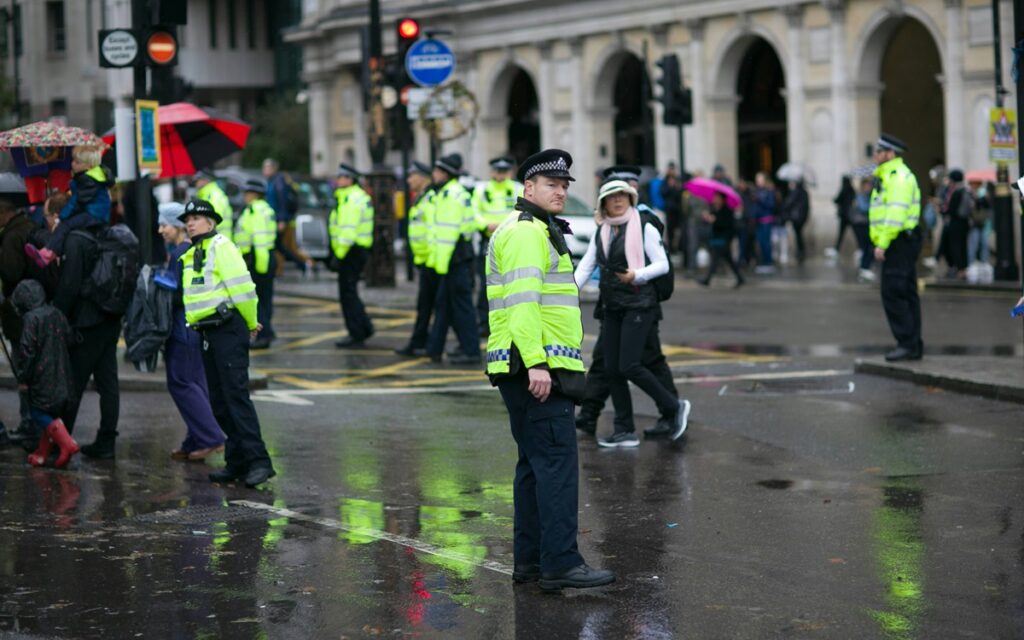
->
[72, 224, 142, 315]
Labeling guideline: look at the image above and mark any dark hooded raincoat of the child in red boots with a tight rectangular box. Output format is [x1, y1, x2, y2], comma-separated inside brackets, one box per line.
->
[12, 280, 74, 415]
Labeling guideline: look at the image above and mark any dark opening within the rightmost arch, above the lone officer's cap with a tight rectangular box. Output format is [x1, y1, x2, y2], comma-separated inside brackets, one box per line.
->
[880, 18, 946, 196]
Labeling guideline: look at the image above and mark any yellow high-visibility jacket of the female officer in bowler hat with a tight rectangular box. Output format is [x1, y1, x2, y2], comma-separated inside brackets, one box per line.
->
[179, 233, 258, 331]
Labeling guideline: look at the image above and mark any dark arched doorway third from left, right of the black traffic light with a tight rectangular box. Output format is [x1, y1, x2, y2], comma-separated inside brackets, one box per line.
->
[736, 38, 788, 179]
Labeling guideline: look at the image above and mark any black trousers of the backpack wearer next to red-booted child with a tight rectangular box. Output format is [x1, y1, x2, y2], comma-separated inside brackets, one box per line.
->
[63, 317, 121, 442]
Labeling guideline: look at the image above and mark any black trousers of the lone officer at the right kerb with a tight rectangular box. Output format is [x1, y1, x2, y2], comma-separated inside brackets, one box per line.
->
[882, 231, 922, 350]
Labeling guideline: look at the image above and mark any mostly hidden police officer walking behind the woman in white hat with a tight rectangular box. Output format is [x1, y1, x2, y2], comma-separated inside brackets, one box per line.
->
[577, 165, 678, 437]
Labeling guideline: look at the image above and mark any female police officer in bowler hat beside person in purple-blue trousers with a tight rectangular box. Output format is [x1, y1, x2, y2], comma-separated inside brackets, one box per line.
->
[178, 200, 274, 487]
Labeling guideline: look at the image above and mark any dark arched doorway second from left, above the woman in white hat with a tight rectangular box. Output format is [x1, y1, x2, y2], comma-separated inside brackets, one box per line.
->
[613, 54, 654, 167]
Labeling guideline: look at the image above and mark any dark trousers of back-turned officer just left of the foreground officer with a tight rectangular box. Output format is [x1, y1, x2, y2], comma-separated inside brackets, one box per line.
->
[427, 260, 480, 356]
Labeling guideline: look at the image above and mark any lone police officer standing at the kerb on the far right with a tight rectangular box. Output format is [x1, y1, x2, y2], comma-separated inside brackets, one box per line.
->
[867, 133, 925, 361]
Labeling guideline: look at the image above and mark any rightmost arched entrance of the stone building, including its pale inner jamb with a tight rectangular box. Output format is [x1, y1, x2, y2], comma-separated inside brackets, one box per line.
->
[858, 16, 942, 195]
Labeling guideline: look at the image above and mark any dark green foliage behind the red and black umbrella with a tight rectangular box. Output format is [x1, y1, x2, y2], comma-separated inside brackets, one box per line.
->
[242, 92, 309, 173]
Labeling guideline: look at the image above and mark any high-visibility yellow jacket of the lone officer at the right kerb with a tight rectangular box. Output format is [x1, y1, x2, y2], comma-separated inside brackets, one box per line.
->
[867, 158, 921, 249]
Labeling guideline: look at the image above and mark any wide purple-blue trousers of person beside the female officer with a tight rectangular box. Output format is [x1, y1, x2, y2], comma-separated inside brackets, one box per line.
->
[164, 336, 224, 452]
